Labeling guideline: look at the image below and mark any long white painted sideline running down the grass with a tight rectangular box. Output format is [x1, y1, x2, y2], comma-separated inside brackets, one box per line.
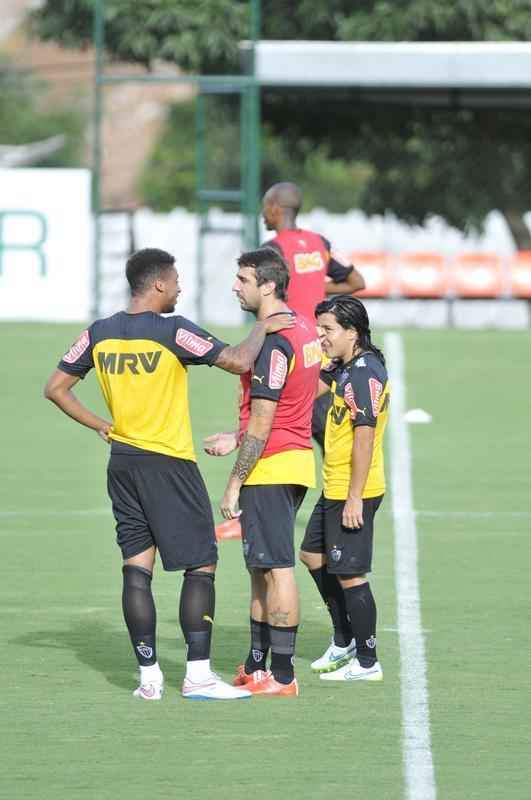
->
[384, 333, 437, 800]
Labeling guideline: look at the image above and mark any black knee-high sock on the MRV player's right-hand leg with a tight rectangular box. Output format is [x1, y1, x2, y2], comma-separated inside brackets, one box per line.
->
[179, 570, 216, 661]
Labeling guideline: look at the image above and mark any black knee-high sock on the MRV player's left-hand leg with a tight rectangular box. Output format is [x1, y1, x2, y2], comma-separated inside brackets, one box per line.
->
[122, 564, 157, 667]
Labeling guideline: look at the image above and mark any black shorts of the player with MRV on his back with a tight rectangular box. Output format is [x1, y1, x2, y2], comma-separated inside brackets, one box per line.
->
[107, 451, 218, 570]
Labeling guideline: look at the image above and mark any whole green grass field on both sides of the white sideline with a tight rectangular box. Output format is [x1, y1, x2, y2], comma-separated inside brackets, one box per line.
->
[0, 324, 531, 800]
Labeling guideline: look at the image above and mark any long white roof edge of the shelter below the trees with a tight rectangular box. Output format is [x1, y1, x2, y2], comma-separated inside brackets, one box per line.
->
[249, 41, 531, 91]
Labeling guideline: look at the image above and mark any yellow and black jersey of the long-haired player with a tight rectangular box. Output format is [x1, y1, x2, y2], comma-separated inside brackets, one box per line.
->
[321, 352, 390, 500]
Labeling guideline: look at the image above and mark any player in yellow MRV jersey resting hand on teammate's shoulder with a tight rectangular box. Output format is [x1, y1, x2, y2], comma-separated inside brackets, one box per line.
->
[45, 249, 293, 700]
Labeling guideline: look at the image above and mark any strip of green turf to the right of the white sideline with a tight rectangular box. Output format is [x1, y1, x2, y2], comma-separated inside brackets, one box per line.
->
[405, 331, 531, 800]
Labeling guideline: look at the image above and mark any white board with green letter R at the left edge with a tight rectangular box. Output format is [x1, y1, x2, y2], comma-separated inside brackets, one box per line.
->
[0, 169, 92, 321]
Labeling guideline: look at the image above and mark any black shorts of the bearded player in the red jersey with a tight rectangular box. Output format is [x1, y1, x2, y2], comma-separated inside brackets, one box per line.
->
[240, 484, 306, 569]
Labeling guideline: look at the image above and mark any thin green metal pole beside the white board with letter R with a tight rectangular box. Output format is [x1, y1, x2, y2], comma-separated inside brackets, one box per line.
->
[92, 0, 105, 317]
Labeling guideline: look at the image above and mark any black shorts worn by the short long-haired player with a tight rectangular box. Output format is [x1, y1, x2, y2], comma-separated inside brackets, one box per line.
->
[301, 495, 383, 575]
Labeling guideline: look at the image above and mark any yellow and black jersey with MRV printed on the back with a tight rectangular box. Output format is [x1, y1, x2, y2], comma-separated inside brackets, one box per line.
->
[58, 311, 226, 461]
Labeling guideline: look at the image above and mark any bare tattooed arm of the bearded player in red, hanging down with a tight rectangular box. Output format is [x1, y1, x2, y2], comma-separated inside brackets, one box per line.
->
[221, 398, 277, 519]
